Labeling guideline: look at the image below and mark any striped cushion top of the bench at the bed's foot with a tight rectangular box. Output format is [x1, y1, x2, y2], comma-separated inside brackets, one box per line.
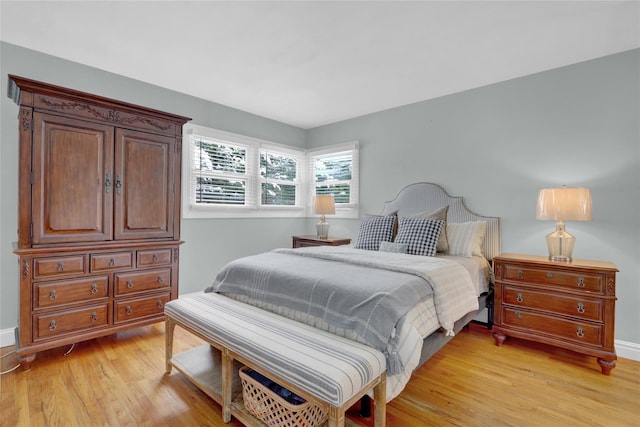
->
[165, 292, 386, 407]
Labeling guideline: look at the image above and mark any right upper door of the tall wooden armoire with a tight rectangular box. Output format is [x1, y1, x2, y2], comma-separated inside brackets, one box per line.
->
[114, 129, 177, 240]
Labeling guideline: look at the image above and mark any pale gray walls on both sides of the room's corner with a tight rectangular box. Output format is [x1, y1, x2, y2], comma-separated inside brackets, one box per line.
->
[0, 43, 640, 344]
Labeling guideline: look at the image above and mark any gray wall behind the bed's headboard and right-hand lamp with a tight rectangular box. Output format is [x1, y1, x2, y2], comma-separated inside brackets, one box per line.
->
[307, 50, 640, 343]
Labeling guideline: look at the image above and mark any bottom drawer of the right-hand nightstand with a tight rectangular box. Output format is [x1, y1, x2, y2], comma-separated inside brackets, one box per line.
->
[502, 307, 603, 347]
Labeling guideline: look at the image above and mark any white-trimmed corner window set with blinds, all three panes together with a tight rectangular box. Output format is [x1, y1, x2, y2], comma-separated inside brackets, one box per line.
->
[182, 125, 358, 218]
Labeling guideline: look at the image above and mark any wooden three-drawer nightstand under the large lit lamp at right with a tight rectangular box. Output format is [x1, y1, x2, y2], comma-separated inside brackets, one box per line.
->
[493, 254, 618, 375]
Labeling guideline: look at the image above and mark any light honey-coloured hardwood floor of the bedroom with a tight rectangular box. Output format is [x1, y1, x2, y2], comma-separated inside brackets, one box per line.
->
[0, 324, 640, 427]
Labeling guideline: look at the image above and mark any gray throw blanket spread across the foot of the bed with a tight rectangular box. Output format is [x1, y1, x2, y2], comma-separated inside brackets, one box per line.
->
[205, 250, 433, 375]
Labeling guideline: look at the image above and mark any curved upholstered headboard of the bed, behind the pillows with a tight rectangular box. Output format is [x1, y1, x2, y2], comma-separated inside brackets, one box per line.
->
[382, 182, 500, 260]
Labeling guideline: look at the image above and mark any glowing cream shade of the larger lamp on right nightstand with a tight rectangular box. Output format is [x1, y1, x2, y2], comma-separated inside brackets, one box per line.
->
[536, 186, 591, 221]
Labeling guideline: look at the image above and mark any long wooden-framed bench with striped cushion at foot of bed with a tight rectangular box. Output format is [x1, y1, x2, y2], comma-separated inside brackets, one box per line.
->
[165, 292, 386, 427]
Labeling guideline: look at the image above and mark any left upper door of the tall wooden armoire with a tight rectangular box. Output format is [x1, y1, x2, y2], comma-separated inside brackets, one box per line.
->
[31, 112, 113, 245]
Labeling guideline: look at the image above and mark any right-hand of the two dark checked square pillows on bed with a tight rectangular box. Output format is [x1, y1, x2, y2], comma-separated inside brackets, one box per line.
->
[394, 218, 444, 256]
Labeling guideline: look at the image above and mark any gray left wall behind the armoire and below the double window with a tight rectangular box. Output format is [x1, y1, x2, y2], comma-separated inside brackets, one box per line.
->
[0, 42, 310, 338]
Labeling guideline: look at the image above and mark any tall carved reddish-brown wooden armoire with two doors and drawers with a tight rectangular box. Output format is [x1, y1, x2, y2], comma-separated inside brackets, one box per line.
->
[8, 75, 190, 370]
